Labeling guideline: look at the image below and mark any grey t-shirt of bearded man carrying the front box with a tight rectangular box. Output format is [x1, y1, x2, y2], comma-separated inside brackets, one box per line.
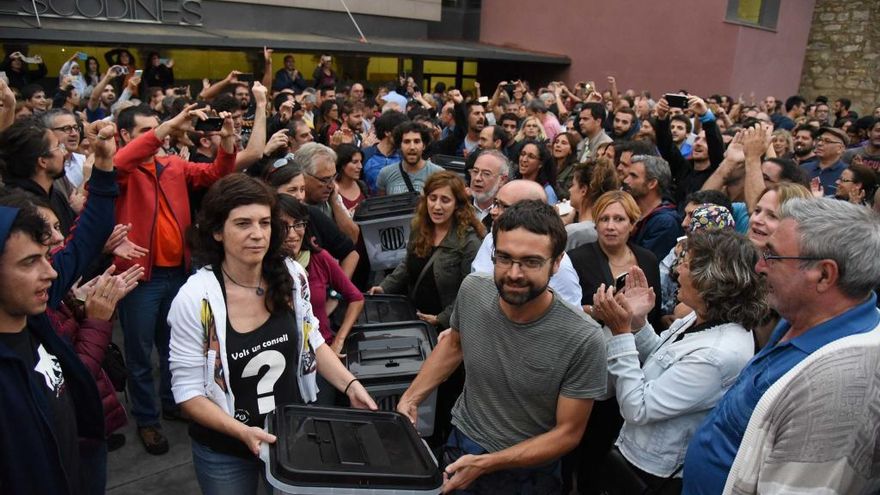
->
[450, 273, 608, 452]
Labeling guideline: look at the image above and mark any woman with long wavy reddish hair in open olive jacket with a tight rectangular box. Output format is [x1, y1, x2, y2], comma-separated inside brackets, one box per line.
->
[370, 171, 485, 330]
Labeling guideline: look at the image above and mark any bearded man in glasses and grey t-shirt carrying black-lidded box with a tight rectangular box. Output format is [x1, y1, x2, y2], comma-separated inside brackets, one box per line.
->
[397, 200, 606, 494]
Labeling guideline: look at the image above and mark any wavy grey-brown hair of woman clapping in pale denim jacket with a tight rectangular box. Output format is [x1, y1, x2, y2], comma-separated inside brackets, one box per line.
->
[687, 229, 769, 330]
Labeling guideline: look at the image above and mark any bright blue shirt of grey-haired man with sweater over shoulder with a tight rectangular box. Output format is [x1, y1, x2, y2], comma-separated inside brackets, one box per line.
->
[682, 292, 880, 495]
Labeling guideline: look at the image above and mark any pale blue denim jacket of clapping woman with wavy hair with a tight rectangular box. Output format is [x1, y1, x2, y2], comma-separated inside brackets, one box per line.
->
[607, 313, 755, 477]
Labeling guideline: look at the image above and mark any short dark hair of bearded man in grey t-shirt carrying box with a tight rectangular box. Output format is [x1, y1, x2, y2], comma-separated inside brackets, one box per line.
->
[492, 199, 568, 259]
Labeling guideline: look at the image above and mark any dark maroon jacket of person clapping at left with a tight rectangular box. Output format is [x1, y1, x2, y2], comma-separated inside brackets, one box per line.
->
[46, 303, 128, 435]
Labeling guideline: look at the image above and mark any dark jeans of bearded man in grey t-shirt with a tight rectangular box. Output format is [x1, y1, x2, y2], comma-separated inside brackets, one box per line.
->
[443, 427, 562, 495]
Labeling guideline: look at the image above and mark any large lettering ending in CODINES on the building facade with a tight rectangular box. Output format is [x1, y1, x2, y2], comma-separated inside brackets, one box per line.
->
[9, 0, 202, 26]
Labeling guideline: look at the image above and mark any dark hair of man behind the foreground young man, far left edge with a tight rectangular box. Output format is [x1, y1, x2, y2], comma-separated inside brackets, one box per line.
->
[0, 117, 50, 180]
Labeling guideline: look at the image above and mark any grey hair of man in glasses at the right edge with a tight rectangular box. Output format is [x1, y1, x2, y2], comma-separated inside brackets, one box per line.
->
[779, 198, 880, 298]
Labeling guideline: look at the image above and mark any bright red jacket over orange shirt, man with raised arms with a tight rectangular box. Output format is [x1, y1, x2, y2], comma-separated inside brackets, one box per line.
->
[113, 131, 235, 280]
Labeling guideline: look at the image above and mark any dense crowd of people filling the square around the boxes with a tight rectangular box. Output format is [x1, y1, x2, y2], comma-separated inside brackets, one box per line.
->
[0, 48, 880, 494]
